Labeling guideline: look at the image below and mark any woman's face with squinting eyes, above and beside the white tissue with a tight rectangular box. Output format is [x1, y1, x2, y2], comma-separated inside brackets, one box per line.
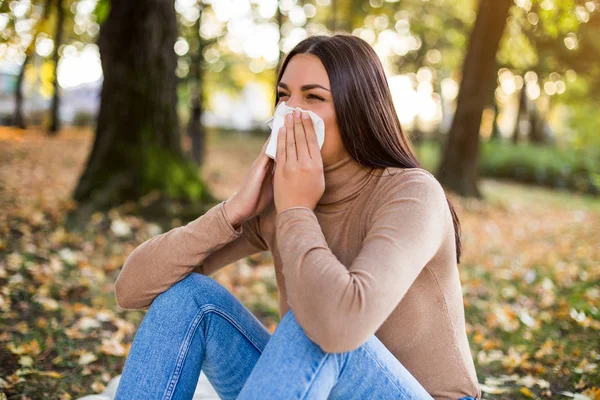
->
[277, 54, 348, 167]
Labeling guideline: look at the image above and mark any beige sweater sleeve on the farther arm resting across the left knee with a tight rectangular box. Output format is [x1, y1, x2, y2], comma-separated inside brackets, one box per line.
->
[115, 201, 267, 309]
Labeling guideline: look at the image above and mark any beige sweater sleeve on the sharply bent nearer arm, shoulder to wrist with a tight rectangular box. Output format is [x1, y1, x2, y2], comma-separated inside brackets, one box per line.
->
[275, 171, 448, 353]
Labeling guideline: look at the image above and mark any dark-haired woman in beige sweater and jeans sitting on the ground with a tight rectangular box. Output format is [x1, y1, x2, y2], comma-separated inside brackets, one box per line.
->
[115, 34, 481, 400]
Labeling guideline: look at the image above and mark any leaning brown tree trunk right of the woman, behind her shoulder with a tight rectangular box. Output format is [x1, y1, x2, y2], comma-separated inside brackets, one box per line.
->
[437, 0, 513, 197]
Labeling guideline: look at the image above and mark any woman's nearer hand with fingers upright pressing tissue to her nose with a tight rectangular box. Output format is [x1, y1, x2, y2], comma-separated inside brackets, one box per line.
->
[273, 110, 325, 214]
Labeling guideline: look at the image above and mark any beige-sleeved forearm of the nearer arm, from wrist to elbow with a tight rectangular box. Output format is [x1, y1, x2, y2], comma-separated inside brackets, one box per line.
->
[277, 207, 370, 352]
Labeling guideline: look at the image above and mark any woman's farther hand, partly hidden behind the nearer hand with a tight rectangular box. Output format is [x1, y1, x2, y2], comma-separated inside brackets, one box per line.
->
[225, 135, 275, 228]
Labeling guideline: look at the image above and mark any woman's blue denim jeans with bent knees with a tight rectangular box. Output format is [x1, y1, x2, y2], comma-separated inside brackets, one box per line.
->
[115, 273, 469, 400]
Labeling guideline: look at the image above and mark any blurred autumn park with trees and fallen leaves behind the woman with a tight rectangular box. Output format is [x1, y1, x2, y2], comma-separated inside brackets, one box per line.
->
[0, 0, 600, 399]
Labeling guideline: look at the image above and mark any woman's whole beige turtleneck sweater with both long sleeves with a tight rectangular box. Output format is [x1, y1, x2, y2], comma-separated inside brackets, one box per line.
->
[115, 157, 481, 400]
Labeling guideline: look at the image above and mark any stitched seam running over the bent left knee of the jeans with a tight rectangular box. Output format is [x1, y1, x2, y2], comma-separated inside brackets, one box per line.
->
[163, 304, 263, 400]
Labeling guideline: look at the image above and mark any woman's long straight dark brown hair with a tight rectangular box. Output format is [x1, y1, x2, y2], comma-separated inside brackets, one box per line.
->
[275, 33, 461, 263]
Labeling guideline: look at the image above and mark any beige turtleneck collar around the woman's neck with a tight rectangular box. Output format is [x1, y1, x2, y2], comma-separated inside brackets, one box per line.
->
[318, 155, 373, 206]
